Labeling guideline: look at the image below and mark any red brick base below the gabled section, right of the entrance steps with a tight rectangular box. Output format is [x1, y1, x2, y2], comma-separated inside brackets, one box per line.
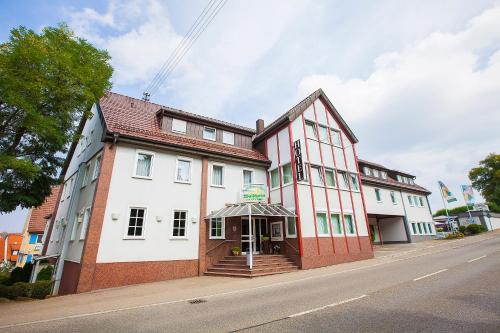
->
[301, 236, 373, 269]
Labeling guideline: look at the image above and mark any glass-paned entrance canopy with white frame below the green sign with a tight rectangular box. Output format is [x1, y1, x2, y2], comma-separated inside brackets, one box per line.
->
[206, 203, 295, 219]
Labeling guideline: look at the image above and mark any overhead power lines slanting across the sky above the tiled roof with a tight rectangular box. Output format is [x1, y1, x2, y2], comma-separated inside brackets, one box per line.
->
[143, 0, 227, 101]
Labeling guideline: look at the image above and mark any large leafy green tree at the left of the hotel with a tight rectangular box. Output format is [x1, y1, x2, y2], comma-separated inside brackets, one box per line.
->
[0, 24, 113, 213]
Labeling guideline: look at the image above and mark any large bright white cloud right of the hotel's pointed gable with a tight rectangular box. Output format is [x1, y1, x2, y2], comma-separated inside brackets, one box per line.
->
[299, 6, 500, 208]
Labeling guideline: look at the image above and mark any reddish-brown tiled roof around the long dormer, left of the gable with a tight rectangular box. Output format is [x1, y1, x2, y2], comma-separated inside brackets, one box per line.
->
[99, 92, 268, 162]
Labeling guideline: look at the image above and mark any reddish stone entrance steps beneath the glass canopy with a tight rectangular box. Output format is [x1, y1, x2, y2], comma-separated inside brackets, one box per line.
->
[205, 254, 299, 278]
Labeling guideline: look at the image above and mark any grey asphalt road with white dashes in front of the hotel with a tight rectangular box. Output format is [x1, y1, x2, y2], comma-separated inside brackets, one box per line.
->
[0, 236, 500, 332]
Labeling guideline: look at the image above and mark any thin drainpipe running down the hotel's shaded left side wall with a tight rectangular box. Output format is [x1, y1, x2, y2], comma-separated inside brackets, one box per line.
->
[52, 162, 86, 295]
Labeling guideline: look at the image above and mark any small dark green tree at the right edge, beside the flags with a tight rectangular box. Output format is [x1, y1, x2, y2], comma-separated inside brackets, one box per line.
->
[469, 154, 500, 210]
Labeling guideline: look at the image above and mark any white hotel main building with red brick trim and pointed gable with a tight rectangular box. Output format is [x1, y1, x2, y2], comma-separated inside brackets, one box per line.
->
[44, 90, 430, 294]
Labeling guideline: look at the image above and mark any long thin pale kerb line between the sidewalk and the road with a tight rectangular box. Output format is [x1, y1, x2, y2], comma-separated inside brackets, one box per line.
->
[0, 236, 496, 329]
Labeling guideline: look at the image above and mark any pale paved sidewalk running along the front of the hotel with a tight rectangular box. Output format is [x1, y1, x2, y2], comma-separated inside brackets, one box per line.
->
[0, 230, 500, 328]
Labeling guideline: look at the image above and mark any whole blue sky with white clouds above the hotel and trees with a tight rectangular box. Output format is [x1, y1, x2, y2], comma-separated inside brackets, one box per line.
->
[0, 0, 500, 231]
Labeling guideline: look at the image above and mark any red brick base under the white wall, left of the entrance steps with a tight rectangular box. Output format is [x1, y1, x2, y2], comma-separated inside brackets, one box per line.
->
[92, 260, 198, 290]
